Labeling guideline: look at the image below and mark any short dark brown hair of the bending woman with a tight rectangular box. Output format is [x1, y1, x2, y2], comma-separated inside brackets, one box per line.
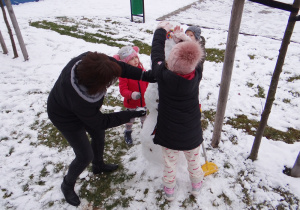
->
[76, 52, 122, 95]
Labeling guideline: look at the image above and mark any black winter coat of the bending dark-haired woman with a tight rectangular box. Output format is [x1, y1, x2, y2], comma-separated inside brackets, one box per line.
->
[47, 52, 146, 131]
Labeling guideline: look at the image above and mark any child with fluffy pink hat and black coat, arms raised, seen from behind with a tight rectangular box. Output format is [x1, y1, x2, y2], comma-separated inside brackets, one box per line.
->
[144, 22, 204, 201]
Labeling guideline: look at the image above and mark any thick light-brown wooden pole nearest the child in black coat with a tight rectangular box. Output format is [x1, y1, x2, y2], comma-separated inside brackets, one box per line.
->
[211, 0, 245, 147]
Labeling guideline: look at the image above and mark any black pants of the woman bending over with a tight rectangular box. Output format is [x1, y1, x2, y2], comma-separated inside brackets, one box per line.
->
[61, 128, 105, 183]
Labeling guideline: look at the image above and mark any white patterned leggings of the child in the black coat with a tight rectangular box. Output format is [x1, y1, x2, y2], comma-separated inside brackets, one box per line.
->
[162, 146, 204, 188]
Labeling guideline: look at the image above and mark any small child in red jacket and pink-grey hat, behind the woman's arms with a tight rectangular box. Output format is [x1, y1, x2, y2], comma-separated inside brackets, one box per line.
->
[113, 46, 148, 144]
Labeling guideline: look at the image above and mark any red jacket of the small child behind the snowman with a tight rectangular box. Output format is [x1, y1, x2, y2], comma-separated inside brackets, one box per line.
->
[119, 64, 149, 109]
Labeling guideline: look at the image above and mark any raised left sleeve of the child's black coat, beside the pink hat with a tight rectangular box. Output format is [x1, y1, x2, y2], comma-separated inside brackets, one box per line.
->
[151, 28, 167, 69]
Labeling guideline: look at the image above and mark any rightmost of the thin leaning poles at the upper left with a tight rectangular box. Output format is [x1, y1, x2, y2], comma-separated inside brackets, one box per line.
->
[4, 0, 28, 61]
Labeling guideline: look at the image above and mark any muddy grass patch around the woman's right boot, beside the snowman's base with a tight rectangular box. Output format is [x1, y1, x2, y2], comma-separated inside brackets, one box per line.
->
[80, 129, 135, 209]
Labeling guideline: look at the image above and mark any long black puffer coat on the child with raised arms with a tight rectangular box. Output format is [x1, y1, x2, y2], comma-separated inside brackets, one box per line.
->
[145, 29, 203, 150]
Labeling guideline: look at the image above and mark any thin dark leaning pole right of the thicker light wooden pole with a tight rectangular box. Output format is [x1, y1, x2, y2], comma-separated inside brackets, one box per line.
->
[249, 0, 300, 161]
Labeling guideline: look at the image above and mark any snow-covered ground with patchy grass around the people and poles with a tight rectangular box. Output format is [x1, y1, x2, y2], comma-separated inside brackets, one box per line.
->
[0, 0, 300, 210]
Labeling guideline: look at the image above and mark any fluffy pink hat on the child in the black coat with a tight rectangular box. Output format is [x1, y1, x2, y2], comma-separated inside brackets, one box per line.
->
[167, 41, 204, 74]
